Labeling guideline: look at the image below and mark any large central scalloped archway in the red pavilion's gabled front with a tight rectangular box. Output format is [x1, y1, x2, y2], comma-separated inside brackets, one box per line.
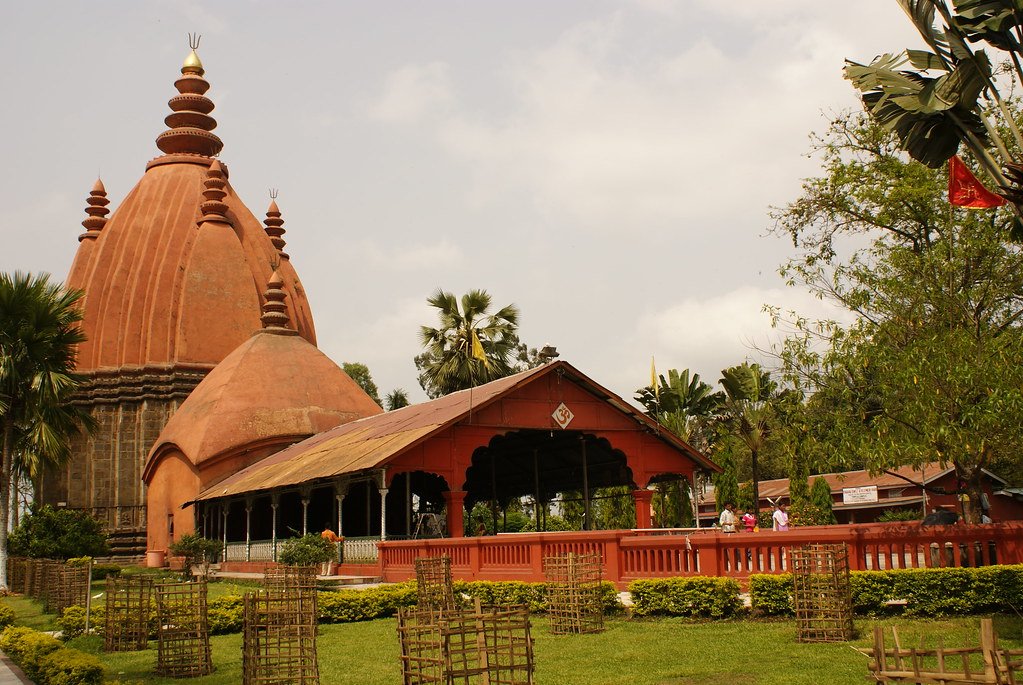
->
[462, 429, 635, 533]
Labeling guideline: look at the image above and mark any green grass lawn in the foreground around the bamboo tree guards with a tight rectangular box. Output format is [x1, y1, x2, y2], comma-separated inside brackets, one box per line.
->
[49, 613, 1023, 685]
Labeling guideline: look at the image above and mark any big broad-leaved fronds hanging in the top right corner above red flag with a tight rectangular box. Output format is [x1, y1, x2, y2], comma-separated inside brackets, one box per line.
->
[845, 0, 1023, 219]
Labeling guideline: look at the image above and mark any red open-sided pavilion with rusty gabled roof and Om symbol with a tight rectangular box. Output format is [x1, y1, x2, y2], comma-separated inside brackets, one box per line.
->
[194, 361, 719, 549]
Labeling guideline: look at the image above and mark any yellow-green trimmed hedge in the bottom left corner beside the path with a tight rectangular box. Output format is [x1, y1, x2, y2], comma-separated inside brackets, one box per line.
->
[0, 628, 103, 685]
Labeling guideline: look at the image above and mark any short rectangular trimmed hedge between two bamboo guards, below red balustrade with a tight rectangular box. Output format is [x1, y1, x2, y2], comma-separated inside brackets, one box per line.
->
[629, 577, 743, 619]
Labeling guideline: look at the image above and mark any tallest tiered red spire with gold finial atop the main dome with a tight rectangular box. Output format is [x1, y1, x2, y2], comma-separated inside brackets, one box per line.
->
[157, 35, 224, 157]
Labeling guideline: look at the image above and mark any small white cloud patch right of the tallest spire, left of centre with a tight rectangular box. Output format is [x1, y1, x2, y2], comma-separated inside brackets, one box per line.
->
[366, 61, 451, 124]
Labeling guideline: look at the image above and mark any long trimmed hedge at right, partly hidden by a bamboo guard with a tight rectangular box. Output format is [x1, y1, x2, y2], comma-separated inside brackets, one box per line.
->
[750, 565, 1023, 617]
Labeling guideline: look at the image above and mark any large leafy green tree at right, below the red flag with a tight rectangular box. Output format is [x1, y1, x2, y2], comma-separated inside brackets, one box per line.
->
[773, 111, 1023, 519]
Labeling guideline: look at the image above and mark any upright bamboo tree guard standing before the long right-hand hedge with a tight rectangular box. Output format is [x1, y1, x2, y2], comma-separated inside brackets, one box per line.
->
[791, 544, 853, 642]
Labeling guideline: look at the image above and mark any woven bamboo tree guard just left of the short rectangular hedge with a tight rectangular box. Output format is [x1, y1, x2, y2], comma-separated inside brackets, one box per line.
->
[543, 552, 604, 635]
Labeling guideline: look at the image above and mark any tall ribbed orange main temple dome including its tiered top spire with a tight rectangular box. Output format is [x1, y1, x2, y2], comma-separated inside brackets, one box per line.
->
[68, 49, 316, 373]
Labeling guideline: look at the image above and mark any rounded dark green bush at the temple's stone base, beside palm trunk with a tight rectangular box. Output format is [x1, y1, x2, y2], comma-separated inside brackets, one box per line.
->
[8, 505, 109, 559]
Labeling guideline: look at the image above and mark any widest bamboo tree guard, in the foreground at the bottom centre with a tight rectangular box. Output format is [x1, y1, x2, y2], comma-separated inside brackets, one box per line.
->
[398, 599, 534, 685]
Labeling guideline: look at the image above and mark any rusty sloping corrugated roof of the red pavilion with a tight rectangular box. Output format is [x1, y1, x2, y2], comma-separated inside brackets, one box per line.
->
[196, 361, 719, 501]
